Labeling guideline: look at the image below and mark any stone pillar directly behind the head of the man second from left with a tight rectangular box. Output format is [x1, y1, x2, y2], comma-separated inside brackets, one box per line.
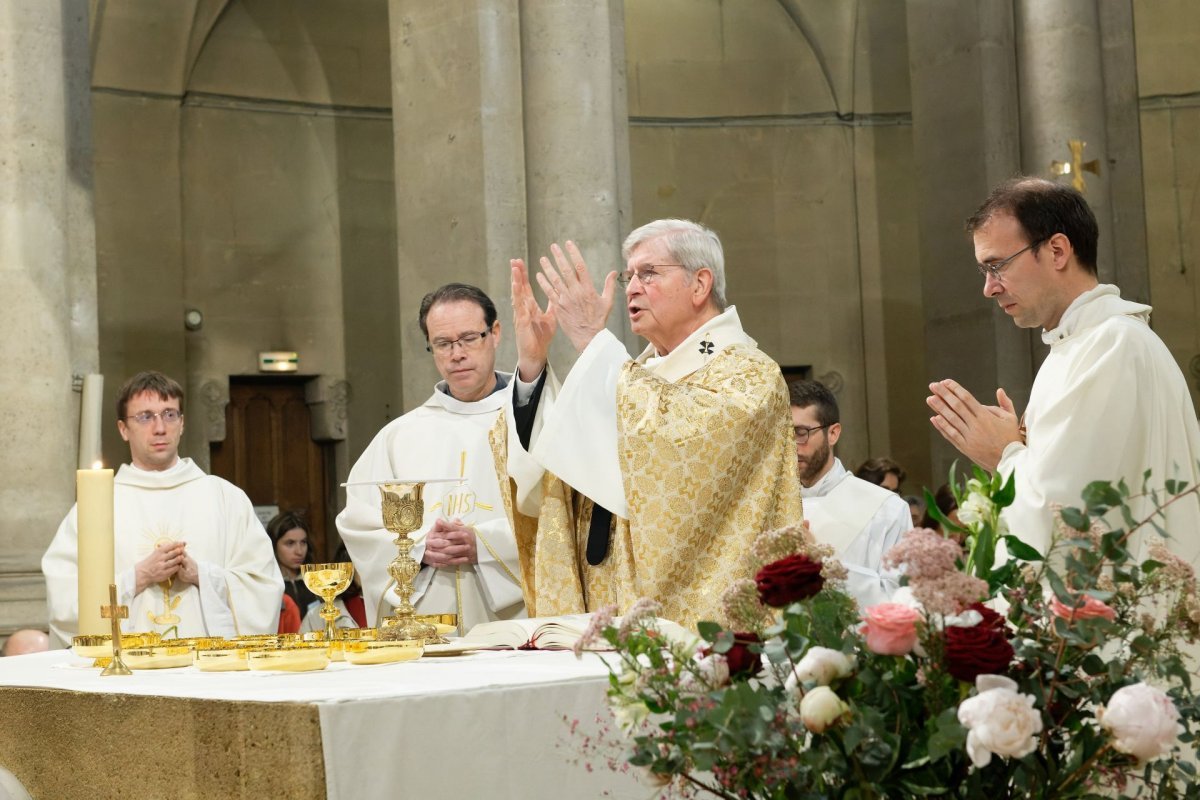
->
[388, 0, 526, 410]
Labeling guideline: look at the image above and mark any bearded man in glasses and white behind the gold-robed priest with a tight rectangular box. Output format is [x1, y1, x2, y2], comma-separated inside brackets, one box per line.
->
[788, 380, 912, 608]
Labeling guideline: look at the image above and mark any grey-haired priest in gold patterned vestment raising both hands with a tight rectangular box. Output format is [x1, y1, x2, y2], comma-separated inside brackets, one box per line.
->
[509, 219, 802, 626]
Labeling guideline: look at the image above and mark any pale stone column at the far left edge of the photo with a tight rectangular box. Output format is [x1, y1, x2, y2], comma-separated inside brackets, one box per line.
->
[0, 0, 99, 632]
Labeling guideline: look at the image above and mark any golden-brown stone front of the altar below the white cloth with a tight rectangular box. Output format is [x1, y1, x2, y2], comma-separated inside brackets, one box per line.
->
[0, 679, 325, 800]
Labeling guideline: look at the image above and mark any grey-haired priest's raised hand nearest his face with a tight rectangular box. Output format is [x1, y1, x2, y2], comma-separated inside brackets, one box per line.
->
[538, 241, 617, 353]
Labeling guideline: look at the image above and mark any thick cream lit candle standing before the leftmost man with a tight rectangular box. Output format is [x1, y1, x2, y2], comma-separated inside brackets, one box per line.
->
[76, 462, 115, 636]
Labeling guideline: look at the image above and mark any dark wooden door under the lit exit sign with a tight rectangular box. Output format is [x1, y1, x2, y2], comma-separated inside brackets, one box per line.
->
[211, 375, 336, 561]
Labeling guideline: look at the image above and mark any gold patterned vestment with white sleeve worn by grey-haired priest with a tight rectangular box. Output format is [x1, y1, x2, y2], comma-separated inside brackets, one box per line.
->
[493, 307, 802, 627]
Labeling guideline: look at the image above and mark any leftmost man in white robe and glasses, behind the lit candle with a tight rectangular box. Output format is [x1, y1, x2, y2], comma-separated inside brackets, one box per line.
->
[42, 372, 283, 646]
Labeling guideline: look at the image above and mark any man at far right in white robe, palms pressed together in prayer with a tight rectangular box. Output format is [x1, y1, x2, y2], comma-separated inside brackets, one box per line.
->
[928, 178, 1200, 563]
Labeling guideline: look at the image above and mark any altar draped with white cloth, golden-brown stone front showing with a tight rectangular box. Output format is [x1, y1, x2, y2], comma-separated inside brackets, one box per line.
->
[0, 650, 653, 800]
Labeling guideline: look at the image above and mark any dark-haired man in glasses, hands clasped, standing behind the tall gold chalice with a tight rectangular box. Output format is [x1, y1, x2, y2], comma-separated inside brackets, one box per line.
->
[337, 283, 546, 630]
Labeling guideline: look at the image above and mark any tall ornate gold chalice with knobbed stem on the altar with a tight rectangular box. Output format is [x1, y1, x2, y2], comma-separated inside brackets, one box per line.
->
[379, 481, 440, 642]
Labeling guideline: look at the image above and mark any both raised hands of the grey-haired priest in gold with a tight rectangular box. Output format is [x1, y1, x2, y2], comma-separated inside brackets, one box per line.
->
[509, 241, 617, 381]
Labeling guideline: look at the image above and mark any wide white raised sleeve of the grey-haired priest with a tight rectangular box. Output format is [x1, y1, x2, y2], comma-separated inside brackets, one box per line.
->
[532, 330, 629, 517]
